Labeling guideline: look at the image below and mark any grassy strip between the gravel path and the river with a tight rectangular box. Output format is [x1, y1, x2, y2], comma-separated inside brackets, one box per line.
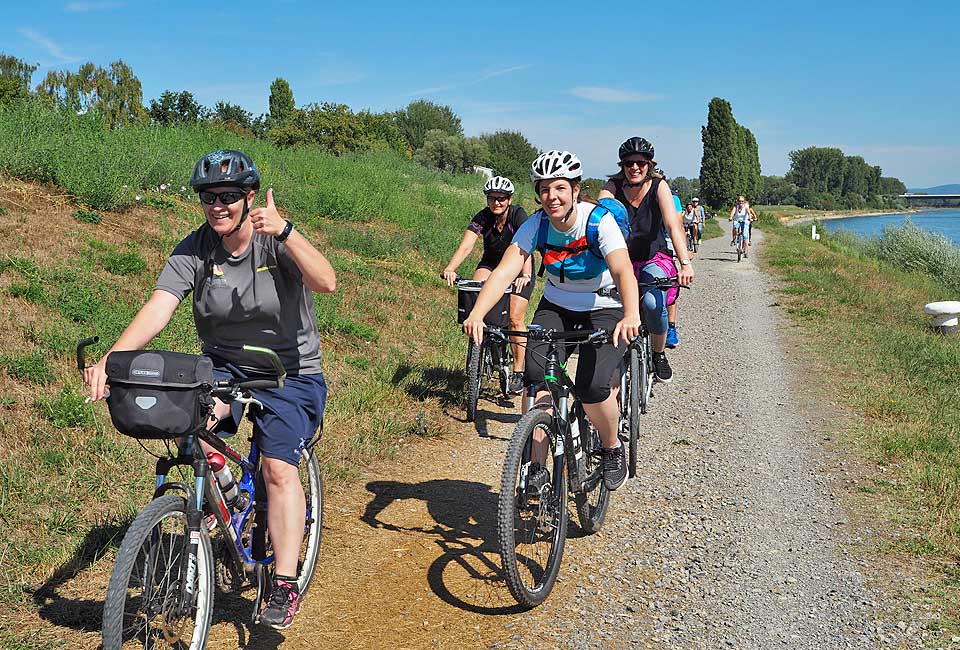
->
[763, 210, 960, 633]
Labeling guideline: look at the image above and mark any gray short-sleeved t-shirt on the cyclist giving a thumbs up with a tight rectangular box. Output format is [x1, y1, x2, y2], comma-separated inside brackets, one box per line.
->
[156, 225, 320, 374]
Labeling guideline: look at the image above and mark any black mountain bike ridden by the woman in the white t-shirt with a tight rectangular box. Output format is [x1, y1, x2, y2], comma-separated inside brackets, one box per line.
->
[487, 326, 611, 608]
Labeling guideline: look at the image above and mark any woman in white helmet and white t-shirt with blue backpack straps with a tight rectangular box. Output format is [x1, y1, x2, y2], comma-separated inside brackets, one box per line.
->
[463, 151, 640, 490]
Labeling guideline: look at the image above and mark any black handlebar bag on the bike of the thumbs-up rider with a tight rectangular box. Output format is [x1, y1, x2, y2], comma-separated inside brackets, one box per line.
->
[107, 350, 214, 438]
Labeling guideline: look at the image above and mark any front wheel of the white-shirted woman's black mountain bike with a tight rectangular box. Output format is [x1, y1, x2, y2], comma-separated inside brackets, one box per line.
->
[497, 409, 569, 608]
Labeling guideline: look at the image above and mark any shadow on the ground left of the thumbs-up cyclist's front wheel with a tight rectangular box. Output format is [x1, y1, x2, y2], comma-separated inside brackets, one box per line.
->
[31, 524, 127, 632]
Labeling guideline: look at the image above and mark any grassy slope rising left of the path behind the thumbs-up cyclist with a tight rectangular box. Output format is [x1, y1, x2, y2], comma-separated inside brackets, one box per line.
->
[0, 100, 532, 648]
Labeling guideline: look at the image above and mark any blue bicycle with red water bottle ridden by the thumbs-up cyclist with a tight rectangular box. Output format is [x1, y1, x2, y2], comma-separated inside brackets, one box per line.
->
[77, 337, 323, 650]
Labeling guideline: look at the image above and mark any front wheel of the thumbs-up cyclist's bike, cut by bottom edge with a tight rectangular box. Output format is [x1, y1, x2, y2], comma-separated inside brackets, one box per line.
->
[103, 494, 214, 650]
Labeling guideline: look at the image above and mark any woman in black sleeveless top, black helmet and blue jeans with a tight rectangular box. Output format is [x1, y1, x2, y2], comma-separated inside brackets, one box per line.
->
[600, 137, 693, 382]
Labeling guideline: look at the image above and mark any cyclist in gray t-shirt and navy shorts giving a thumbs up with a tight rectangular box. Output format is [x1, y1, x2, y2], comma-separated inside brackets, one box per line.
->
[84, 150, 336, 629]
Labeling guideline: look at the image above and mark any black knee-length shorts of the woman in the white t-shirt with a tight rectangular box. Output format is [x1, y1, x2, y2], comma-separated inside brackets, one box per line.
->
[524, 299, 624, 404]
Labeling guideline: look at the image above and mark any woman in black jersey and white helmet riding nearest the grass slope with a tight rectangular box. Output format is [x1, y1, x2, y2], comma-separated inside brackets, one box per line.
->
[443, 176, 535, 394]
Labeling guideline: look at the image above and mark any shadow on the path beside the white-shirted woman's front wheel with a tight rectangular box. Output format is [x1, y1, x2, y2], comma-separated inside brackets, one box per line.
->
[361, 479, 523, 615]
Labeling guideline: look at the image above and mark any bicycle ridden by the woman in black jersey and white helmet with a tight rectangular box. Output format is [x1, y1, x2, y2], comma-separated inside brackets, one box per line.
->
[452, 275, 513, 422]
